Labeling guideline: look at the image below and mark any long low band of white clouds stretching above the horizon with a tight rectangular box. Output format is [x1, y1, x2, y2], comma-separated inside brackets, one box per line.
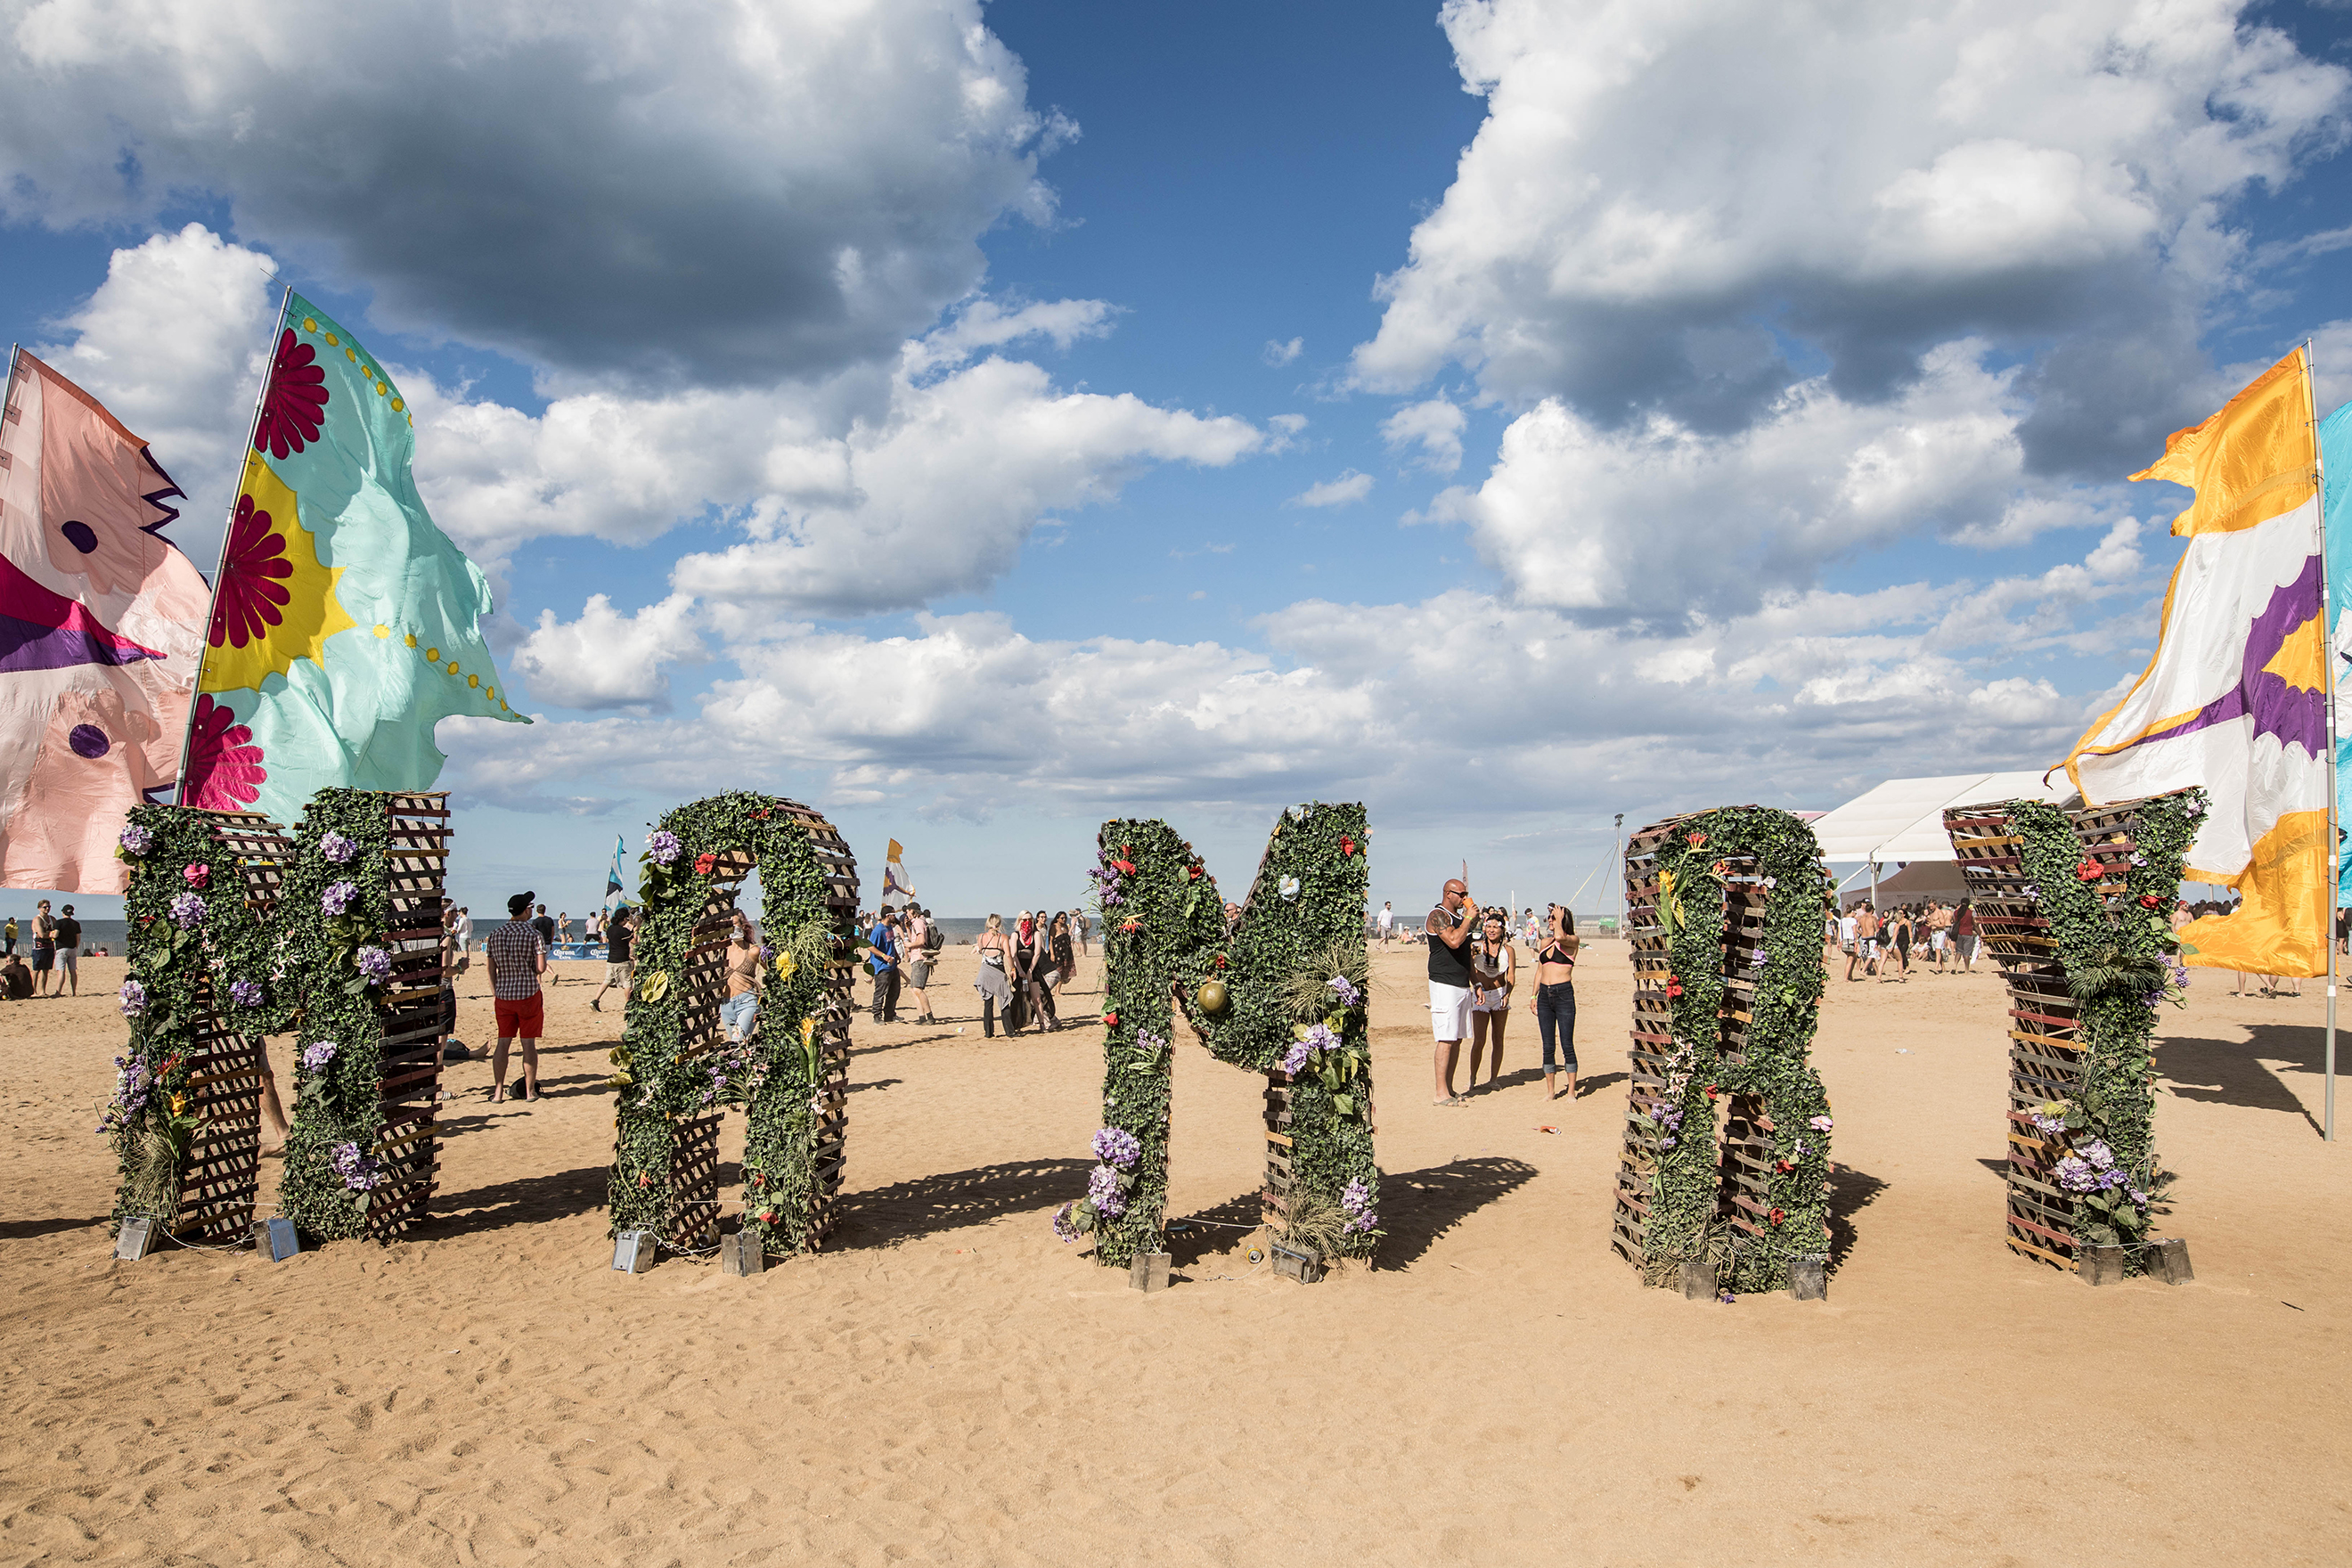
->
[432, 522, 2160, 823]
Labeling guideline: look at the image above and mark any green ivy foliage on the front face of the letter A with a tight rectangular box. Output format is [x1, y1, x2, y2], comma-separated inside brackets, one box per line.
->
[609, 792, 859, 1253]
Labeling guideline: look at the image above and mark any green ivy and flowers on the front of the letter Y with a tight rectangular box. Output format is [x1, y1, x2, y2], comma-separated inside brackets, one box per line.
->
[2011, 788, 2206, 1274]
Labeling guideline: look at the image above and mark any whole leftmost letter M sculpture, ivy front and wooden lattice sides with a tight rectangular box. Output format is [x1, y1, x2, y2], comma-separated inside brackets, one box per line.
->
[102, 790, 449, 1244]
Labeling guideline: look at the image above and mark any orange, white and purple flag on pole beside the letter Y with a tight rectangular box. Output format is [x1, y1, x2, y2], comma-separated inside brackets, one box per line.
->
[2065, 348, 2331, 976]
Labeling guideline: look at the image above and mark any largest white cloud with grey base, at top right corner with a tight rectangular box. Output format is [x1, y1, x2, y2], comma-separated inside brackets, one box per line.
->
[1355, 0, 2352, 470]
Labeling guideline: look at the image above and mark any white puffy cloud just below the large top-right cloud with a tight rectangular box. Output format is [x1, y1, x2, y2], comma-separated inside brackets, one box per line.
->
[1427, 343, 2128, 621]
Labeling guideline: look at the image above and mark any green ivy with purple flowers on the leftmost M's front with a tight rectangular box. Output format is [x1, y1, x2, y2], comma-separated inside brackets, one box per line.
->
[102, 790, 404, 1241]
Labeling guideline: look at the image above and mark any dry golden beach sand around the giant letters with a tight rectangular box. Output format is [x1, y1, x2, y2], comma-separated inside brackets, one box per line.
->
[0, 945, 2352, 1565]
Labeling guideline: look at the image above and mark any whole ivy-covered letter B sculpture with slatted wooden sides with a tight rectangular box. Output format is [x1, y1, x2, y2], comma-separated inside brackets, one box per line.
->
[1609, 806, 1830, 1293]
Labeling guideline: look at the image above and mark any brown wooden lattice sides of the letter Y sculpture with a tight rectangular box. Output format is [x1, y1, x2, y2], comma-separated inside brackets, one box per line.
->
[1943, 799, 2140, 1272]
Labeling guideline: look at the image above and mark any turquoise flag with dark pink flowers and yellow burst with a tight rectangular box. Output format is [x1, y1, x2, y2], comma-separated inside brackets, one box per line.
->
[184, 290, 529, 823]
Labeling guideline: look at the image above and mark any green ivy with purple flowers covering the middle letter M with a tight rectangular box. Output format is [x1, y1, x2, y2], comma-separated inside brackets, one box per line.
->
[1056, 802, 1381, 1267]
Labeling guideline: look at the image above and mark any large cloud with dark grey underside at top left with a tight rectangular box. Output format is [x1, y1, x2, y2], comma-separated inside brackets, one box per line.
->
[0, 0, 1074, 383]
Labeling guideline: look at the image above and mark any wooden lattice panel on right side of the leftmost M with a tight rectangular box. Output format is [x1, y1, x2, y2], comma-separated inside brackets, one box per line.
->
[367, 792, 452, 1241]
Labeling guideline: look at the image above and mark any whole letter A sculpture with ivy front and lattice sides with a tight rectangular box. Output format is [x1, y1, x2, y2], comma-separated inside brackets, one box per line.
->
[611, 795, 859, 1253]
